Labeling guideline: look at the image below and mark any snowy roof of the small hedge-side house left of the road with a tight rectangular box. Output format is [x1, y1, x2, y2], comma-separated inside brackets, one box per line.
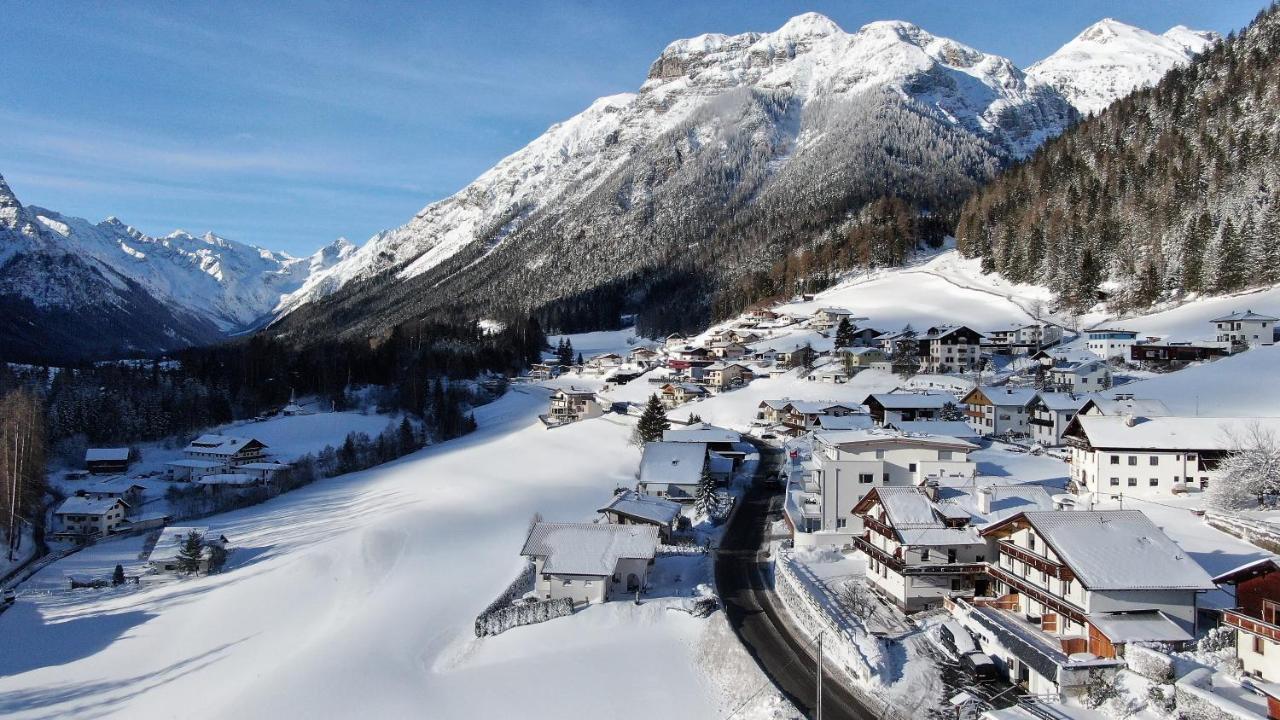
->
[520, 523, 658, 577]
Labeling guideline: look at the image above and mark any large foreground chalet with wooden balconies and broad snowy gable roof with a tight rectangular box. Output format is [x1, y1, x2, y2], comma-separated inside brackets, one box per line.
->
[948, 510, 1213, 694]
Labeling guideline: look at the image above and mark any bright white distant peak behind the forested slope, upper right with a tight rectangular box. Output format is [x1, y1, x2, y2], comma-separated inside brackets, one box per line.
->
[1027, 18, 1221, 115]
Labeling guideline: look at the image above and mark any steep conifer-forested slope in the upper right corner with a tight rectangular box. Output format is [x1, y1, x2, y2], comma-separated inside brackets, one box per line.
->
[956, 5, 1280, 313]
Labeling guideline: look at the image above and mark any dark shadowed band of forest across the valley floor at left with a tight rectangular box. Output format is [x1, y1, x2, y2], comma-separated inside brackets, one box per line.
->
[0, 311, 547, 456]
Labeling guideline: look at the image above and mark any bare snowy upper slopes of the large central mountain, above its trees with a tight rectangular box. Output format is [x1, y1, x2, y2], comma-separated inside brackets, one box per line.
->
[272, 13, 1073, 314]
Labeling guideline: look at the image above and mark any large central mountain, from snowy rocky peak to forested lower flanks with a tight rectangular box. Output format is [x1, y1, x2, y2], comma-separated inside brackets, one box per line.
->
[274, 14, 1075, 340]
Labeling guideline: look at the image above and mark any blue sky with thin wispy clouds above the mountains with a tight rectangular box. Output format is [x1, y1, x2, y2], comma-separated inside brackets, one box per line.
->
[0, 0, 1263, 254]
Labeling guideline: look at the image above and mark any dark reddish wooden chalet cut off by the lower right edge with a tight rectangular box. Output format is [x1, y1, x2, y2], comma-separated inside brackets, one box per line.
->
[1213, 557, 1280, 681]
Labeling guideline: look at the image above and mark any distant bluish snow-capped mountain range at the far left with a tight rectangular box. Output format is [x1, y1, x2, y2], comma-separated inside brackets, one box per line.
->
[0, 178, 355, 357]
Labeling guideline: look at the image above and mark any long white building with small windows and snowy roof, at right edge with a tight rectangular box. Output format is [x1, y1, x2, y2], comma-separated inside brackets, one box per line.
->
[1062, 414, 1280, 497]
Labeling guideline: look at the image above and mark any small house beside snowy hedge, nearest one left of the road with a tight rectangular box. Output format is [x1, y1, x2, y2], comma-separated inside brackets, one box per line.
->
[520, 523, 658, 606]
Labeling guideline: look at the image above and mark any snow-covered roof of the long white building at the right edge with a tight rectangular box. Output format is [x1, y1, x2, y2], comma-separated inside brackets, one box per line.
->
[1071, 415, 1280, 451]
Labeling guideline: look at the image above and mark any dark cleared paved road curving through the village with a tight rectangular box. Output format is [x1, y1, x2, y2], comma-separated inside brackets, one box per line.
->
[716, 448, 876, 720]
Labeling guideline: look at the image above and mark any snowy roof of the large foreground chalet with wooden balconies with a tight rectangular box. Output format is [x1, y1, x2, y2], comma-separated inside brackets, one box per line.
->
[983, 510, 1215, 591]
